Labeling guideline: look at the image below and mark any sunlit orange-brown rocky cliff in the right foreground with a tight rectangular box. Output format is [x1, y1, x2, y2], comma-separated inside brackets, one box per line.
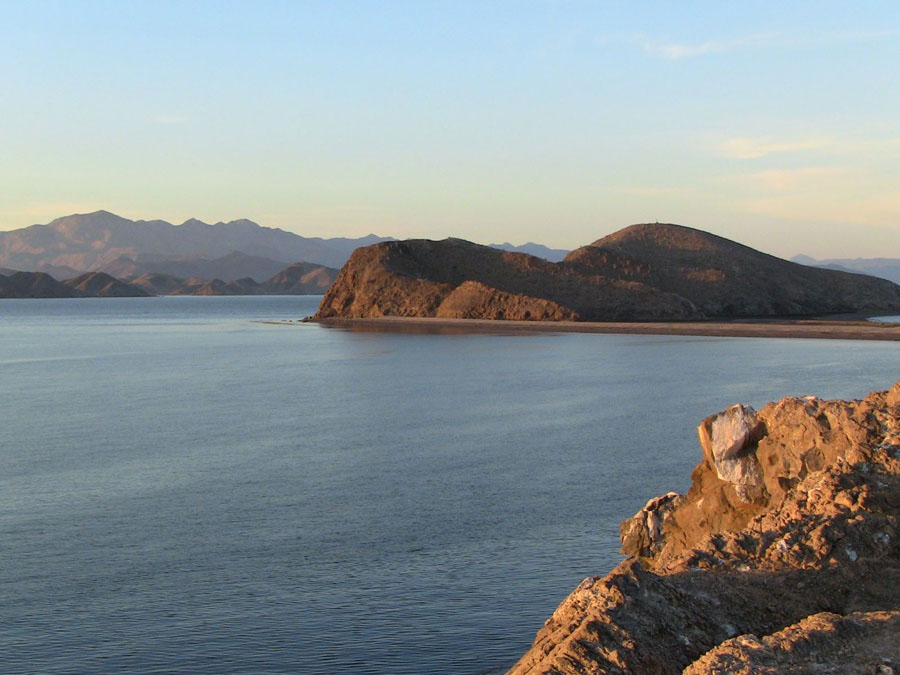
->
[510, 383, 900, 675]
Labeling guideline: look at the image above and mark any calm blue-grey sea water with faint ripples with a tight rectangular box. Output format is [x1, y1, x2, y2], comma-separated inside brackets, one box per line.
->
[0, 297, 900, 674]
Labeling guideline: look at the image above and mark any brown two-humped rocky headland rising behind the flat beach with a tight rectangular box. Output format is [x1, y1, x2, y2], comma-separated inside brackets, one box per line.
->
[315, 223, 900, 321]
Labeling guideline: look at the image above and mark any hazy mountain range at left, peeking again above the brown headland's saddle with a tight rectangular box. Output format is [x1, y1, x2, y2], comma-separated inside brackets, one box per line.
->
[0, 211, 566, 283]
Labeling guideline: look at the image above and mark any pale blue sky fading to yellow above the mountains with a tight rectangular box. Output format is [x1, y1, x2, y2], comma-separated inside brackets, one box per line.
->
[0, 0, 900, 258]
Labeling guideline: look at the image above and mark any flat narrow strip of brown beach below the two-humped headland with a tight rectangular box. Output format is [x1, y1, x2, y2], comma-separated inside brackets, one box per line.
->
[312, 316, 900, 342]
